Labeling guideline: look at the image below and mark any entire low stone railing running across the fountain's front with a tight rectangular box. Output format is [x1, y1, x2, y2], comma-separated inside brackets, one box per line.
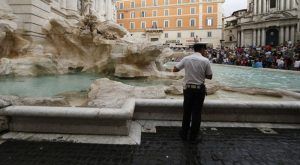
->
[0, 99, 300, 136]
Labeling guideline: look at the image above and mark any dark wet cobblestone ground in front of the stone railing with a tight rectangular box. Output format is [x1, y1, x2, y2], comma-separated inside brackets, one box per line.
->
[0, 127, 300, 165]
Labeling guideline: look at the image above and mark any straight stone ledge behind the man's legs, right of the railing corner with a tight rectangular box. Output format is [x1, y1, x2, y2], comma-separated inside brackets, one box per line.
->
[134, 99, 300, 123]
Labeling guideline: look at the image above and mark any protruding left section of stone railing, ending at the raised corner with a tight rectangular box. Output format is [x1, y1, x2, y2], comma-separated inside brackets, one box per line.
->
[0, 99, 135, 135]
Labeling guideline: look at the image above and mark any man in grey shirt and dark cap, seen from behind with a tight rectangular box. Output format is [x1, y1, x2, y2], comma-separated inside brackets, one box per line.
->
[173, 43, 212, 142]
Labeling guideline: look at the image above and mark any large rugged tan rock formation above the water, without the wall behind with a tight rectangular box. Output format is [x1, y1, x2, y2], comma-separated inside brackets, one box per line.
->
[0, 0, 177, 78]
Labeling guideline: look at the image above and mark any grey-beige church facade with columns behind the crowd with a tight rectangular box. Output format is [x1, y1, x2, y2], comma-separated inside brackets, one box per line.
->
[225, 0, 300, 46]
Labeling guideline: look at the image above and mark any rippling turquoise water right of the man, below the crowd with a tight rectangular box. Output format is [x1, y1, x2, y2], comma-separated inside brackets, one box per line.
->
[212, 65, 300, 91]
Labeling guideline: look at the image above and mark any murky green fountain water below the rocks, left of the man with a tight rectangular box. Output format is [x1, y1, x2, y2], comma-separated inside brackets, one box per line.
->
[0, 74, 171, 97]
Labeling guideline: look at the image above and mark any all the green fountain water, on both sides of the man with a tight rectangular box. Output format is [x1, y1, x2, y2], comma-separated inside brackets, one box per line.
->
[0, 65, 300, 97]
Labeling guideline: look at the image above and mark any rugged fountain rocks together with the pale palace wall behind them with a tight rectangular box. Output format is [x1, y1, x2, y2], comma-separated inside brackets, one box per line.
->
[0, 0, 168, 77]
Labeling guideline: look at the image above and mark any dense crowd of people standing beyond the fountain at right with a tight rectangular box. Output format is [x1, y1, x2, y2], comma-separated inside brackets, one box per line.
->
[207, 41, 300, 71]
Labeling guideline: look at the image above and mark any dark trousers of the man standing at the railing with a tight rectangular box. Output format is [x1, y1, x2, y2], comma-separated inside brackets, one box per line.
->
[182, 85, 205, 140]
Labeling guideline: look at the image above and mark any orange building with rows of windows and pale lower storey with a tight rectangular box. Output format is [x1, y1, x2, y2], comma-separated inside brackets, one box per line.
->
[116, 0, 224, 47]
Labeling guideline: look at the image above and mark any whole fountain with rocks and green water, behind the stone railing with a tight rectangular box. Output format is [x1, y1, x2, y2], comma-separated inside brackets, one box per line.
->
[0, 0, 300, 108]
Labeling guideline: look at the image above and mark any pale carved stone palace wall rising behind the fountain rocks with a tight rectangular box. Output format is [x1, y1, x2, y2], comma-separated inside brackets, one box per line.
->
[5, 0, 116, 39]
